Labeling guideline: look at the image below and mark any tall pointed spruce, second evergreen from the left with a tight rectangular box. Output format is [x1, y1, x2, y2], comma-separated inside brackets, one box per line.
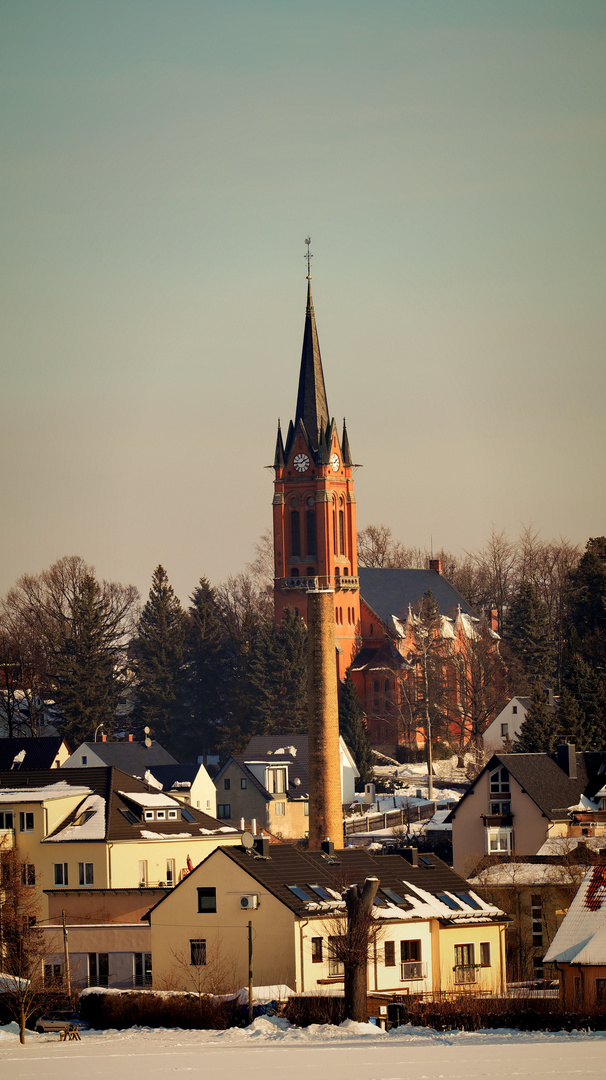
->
[132, 566, 187, 755]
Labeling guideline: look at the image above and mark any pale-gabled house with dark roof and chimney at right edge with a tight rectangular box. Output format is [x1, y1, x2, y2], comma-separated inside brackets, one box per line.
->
[447, 743, 606, 876]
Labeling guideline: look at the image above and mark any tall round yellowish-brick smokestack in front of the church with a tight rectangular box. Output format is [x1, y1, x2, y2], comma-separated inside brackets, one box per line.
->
[307, 590, 344, 851]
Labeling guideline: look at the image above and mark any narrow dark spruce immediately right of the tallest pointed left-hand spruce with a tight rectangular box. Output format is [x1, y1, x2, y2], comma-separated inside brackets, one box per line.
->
[184, 578, 225, 758]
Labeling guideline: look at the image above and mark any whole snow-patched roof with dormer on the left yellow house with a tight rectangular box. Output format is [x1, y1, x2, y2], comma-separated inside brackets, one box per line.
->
[0, 766, 231, 843]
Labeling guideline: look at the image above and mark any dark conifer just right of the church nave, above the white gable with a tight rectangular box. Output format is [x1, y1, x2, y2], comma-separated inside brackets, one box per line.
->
[504, 581, 554, 687]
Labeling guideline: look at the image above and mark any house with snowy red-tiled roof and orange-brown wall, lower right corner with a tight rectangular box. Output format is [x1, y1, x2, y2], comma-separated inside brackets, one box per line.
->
[544, 866, 606, 1009]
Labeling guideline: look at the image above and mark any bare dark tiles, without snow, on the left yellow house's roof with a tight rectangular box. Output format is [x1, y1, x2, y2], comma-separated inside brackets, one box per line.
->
[0, 766, 229, 843]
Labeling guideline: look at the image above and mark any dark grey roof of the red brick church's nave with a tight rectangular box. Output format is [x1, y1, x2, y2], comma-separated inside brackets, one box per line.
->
[359, 567, 473, 625]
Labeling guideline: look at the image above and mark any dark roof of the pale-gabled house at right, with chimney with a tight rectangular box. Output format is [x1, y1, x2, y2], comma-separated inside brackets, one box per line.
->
[446, 751, 606, 821]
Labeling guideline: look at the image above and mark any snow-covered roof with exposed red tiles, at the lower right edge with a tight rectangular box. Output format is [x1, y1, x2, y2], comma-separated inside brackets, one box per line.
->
[544, 866, 606, 966]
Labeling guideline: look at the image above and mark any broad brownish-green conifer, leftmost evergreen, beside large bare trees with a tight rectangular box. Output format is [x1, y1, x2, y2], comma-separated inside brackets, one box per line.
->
[51, 573, 120, 746]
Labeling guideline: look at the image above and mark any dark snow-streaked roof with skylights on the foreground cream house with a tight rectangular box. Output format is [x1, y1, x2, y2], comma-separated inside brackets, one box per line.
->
[151, 843, 503, 924]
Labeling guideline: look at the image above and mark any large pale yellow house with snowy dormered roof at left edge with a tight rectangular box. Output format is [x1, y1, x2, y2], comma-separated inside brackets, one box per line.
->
[0, 767, 240, 921]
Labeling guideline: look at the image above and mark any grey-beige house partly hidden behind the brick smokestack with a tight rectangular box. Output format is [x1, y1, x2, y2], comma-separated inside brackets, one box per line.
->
[215, 735, 360, 839]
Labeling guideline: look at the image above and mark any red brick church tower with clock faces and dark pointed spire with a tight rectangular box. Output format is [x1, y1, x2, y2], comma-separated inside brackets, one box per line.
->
[273, 249, 360, 679]
